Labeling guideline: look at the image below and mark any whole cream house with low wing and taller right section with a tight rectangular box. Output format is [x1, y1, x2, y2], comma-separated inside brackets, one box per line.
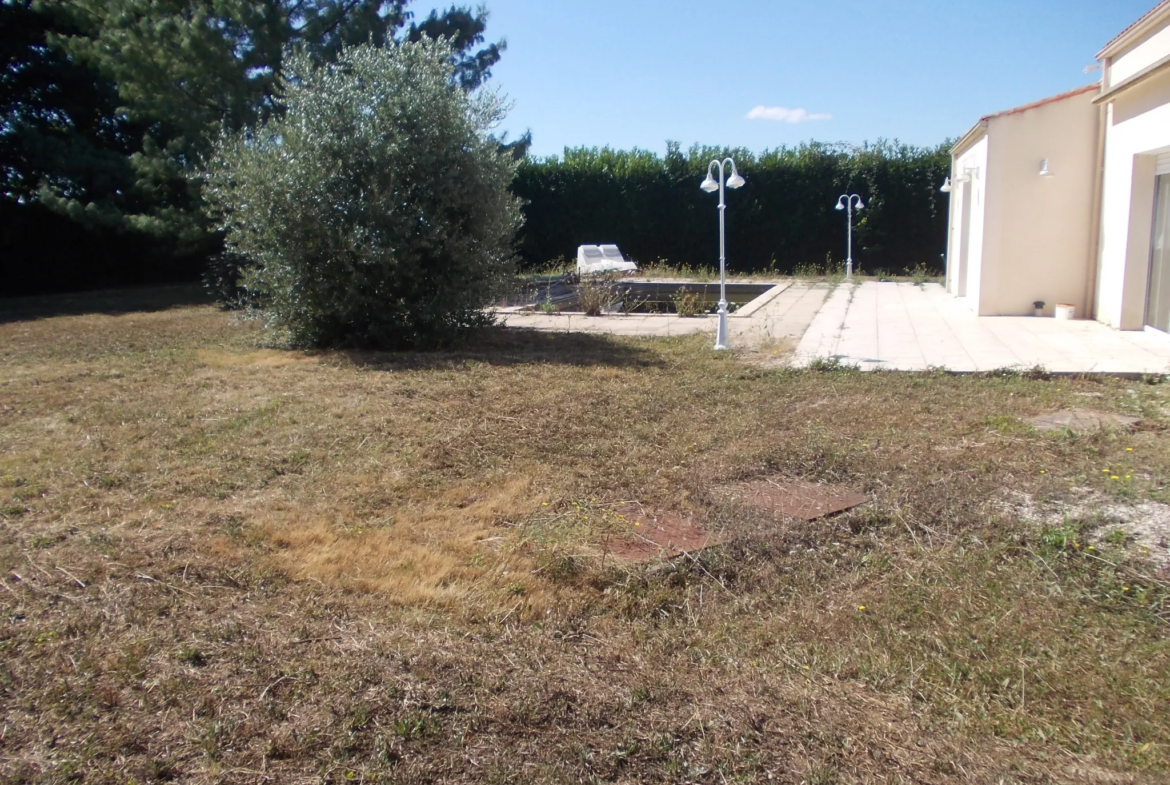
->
[944, 0, 1170, 332]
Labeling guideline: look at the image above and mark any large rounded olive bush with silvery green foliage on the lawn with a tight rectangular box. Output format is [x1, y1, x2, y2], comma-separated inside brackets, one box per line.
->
[206, 40, 522, 349]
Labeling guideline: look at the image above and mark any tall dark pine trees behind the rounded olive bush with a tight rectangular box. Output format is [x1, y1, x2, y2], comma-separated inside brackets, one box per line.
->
[10, 0, 503, 254]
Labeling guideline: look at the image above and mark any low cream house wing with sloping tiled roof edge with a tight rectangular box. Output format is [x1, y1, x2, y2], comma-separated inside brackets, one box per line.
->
[943, 84, 1099, 316]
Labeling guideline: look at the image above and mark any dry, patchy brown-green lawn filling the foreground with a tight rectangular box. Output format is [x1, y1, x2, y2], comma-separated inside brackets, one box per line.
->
[0, 292, 1170, 783]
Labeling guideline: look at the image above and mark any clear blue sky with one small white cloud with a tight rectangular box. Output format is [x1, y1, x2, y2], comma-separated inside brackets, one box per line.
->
[423, 0, 1156, 156]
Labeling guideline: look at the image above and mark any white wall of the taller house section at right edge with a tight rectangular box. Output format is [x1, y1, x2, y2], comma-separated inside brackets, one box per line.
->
[1096, 72, 1170, 330]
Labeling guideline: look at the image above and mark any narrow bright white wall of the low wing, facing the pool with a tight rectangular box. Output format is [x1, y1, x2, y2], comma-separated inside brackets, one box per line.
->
[947, 135, 987, 309]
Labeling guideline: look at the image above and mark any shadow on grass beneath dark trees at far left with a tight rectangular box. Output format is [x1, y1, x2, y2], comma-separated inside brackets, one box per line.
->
[0, 283, 214, 324]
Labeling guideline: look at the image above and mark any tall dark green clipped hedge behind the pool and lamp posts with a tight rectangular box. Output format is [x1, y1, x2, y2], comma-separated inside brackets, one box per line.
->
[512, 142, 950, 273]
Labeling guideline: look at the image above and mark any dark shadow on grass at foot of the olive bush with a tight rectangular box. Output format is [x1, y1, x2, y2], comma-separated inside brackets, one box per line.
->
[339, 326, 665, 371]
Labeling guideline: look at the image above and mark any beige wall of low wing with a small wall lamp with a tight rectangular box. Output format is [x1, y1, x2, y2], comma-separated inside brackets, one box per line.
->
[978, 92, 1099, 316]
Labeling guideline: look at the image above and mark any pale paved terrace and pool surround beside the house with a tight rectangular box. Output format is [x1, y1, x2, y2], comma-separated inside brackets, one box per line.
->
[501, 281, 1170, 373]
